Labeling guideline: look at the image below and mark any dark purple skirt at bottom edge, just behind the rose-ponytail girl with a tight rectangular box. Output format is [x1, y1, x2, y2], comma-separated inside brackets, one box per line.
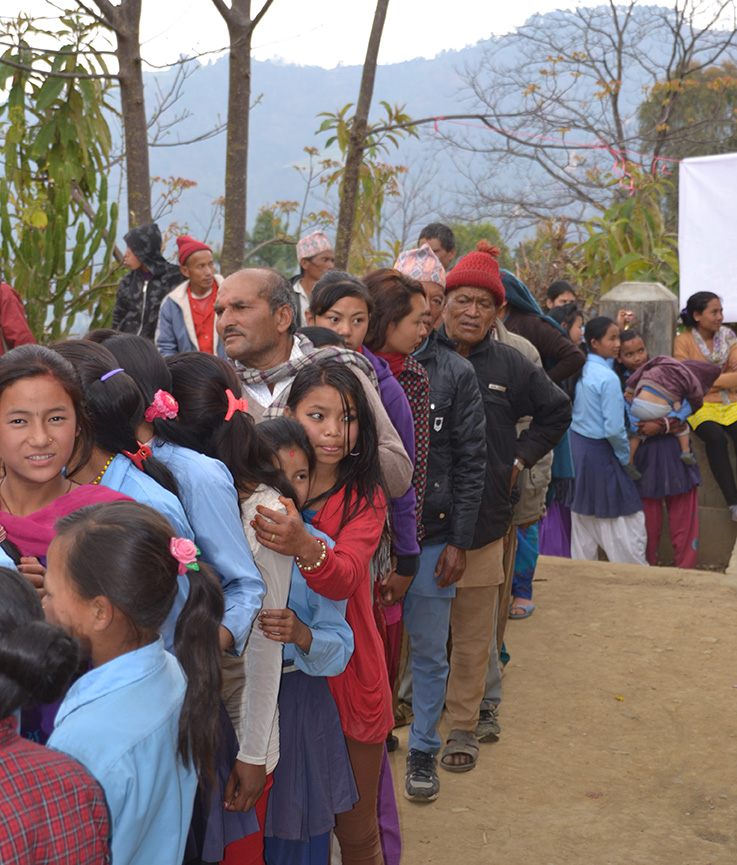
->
[184, 703, 259, 863]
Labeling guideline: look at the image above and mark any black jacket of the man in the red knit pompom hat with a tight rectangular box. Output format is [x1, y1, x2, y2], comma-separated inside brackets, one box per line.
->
[440, 325, 571, 550]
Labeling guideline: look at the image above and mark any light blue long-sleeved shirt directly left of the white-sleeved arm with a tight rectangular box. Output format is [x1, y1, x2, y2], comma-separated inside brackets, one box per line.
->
[151, 439, 266, 655]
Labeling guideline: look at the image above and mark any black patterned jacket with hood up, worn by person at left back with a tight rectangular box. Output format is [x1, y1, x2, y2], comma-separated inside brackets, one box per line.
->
[113, 222, 187, 339]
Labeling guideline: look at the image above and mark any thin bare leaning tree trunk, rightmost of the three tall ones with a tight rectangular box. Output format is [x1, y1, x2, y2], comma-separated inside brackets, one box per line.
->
[335, 0, 389, 270]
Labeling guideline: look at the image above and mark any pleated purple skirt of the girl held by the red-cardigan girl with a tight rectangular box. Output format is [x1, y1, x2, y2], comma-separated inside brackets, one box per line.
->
[264, 670, 358, 841]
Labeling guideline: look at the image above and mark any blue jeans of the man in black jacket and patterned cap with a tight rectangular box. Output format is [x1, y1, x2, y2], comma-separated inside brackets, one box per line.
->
[404, 544, 455, 754]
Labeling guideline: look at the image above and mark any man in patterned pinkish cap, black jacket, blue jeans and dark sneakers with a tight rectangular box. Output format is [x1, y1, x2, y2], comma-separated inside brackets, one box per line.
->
[395, 246, 486, 802]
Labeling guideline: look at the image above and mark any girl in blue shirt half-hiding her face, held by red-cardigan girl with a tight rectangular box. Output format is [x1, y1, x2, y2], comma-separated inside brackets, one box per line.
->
[257, 418, 358, 865]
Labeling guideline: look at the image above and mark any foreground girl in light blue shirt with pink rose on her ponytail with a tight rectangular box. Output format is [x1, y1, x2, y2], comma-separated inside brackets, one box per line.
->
[45, 502, 223, 865]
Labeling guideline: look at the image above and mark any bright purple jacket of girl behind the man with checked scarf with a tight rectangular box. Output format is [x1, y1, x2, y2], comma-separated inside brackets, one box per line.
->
[361, 345, 420, 576]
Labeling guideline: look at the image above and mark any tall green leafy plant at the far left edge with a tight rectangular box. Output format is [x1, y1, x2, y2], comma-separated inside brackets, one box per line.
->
[0, 13, 117, 341]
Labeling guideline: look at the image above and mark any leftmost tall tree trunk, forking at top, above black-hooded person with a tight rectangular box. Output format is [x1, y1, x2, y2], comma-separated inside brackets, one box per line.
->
[88, 0, 152, 228]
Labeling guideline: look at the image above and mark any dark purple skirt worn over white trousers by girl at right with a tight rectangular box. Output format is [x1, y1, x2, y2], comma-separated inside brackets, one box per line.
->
[571, 430, 642, 520]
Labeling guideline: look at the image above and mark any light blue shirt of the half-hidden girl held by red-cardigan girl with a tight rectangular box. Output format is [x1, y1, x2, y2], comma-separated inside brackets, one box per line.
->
[283, 512, 353, 676]
